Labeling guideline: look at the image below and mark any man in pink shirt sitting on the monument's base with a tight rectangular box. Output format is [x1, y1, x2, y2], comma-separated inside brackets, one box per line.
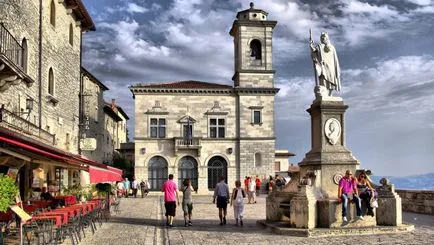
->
[338, 170, 363, 222]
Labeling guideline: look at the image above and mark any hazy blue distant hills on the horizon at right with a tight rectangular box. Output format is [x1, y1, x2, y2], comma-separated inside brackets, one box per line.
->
[371, 173, 434, 190]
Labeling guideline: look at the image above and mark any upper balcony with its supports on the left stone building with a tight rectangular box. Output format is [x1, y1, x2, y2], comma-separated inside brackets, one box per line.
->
[0, 23, 34, 92]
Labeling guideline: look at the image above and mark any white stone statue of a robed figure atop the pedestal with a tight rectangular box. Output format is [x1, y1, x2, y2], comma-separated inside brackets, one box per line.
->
[310, 31, 341, 96]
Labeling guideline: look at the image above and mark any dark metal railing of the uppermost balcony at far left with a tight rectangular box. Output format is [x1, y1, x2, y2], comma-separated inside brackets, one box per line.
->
[0, 23, 24, 70]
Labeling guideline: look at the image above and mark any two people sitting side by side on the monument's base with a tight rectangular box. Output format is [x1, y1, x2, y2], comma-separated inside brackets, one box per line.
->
[338, 170, 378, 222]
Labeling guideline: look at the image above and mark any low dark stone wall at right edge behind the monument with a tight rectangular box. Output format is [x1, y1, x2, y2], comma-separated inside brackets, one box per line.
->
[396, 190, 434, 215]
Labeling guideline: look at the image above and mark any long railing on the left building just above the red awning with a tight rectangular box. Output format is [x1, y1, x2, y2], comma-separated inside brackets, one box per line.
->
[0, 106, 55, 145]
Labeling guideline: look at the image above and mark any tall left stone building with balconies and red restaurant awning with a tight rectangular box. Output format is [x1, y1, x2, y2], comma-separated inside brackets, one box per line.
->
[0, 0, 122, 199]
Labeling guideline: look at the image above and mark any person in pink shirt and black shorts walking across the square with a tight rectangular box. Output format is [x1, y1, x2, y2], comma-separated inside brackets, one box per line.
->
[161, 174, 179, 227]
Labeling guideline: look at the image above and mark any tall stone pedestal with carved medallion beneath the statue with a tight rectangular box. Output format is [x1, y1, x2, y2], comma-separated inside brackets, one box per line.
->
[299, 97, 360, 199]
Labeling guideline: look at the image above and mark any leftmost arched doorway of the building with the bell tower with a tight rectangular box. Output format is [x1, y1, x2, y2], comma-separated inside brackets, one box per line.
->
[148, 156, 169, 191]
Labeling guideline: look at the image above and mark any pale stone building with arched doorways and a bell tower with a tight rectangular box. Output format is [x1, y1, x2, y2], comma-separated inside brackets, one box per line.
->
[130, 6, 279, 193]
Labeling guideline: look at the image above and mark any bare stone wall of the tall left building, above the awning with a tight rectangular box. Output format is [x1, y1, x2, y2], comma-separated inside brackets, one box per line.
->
[0, 0, 94, 153]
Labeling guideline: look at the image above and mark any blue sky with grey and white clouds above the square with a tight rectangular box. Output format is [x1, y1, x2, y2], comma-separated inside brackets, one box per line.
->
[79, 0, 434, 176]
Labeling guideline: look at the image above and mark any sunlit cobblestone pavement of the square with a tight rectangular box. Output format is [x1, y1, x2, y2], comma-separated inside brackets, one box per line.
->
[75, 193, 434, 245]
